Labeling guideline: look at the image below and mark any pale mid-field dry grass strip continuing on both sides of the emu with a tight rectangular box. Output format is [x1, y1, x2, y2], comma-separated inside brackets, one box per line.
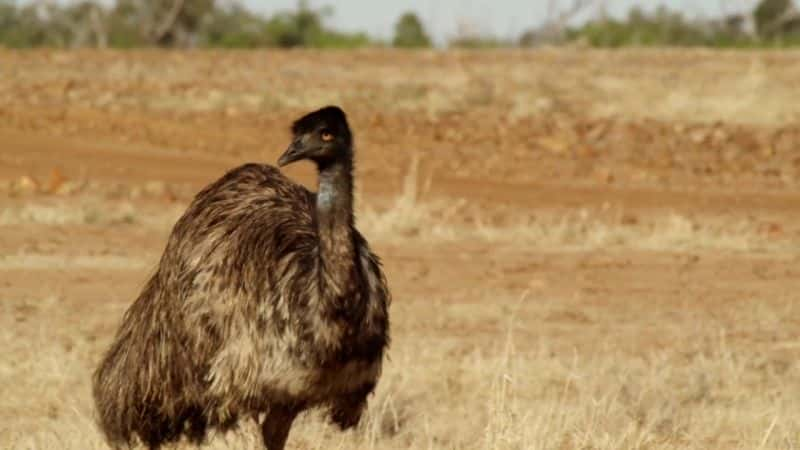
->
[0, 182, 800, 253]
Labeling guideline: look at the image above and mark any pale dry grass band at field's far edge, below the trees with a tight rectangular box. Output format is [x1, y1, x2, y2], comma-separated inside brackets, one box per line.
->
[6, 49, 800, 124]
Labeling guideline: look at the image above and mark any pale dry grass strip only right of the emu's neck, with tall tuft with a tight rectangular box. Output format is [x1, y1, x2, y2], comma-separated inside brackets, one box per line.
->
[359, 161, 800, 253]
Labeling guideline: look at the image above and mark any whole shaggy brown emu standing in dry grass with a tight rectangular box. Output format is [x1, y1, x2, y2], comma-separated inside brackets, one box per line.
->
[93, 106, 390, 450]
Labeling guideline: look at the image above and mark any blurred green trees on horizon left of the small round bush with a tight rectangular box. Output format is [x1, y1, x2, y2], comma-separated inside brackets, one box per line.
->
[0, 0, 371, 48]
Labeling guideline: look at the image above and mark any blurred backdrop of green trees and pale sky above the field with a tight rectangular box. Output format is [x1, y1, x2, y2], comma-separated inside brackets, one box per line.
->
[0, 0, 800, 48]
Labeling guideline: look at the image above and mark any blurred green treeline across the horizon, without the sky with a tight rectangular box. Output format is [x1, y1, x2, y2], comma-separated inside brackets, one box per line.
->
[0, 0, 800, 48]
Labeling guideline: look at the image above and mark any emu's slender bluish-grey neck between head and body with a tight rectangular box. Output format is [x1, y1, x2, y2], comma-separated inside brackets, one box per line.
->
[317, 160, 355, 294]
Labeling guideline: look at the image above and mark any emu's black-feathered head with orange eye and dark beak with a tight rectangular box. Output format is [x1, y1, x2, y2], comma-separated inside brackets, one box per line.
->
[278, 106, 353, 167]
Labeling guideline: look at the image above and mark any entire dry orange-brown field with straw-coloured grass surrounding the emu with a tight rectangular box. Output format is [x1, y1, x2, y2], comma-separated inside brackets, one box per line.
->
[0, 49, 800, 450]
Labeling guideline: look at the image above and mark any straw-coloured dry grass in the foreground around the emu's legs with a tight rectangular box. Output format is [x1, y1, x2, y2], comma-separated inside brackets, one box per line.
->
[0, 292, 800, 449]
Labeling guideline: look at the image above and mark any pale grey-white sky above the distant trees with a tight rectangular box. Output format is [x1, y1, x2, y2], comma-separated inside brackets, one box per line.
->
[243, 0, 757, 43]
